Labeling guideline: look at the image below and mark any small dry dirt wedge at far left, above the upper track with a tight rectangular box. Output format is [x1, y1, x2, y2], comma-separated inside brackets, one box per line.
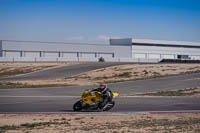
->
[0, 62, 75, 77]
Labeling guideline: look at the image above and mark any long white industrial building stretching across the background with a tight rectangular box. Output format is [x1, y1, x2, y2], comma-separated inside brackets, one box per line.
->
[0, 38, 200, 62]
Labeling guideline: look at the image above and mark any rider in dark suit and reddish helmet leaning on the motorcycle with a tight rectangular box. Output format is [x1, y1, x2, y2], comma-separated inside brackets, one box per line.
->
[93, 83, 113, 109]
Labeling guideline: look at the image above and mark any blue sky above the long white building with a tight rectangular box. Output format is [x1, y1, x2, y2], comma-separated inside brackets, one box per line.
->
[0, 0, 200, 43]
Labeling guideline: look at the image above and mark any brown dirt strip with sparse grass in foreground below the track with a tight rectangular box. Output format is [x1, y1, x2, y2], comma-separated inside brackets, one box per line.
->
[0, 113, 200, 133]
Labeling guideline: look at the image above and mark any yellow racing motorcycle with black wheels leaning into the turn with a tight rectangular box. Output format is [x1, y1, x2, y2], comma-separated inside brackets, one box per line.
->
[73, 89, 119, 111]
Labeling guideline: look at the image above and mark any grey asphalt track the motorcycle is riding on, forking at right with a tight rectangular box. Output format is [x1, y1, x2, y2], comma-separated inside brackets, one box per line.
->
[0, 73, 200, 113]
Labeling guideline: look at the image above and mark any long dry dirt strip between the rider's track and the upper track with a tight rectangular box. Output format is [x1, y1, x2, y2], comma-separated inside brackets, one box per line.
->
[5, 64, 200, 86]
